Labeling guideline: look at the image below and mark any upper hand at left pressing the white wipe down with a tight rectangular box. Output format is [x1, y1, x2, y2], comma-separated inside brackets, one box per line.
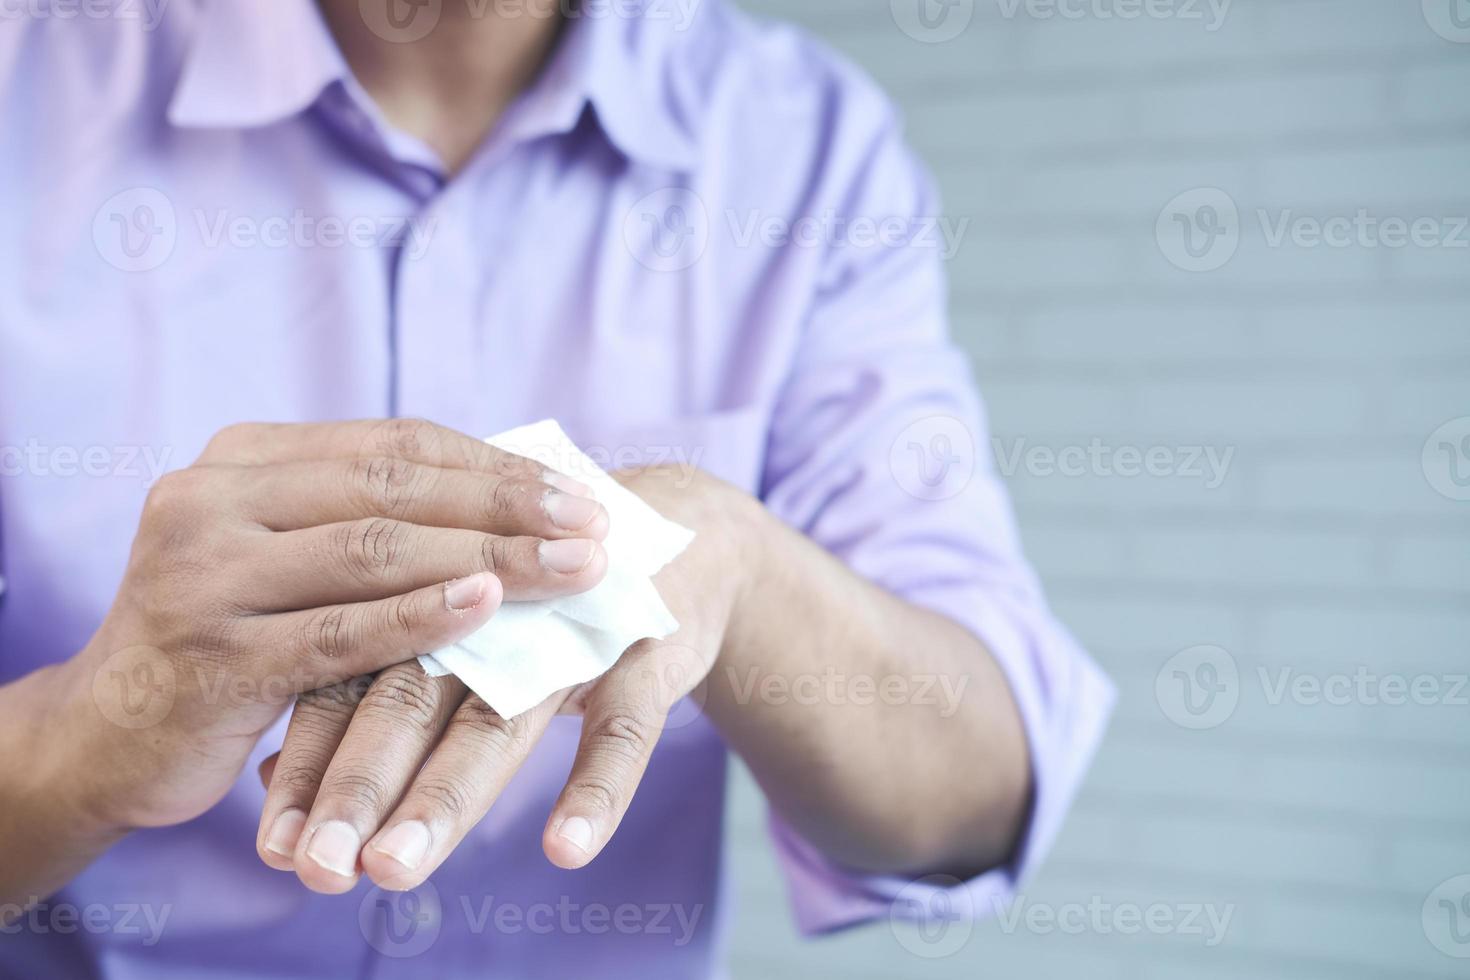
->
[53, 420, 607, 830]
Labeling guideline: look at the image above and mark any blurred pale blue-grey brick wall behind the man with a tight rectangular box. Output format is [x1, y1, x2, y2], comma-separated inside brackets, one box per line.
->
[729, 0, 1470, 980]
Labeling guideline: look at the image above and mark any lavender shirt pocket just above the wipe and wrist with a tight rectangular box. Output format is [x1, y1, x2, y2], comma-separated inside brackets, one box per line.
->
[563, 406, 767, 494]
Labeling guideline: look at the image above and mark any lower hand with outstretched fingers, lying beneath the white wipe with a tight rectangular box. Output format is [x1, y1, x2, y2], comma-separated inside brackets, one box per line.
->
[257, 467, 759, 893]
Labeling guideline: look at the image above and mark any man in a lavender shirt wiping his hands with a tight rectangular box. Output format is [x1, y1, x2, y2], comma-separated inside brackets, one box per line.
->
[0, 0, 1111, 979]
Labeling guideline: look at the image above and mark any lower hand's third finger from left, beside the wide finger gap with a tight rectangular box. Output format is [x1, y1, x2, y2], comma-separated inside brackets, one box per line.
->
[362, 695, 559, 890]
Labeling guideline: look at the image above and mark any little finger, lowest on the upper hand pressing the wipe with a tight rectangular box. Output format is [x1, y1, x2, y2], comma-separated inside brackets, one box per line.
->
[246, 572, 501, 692]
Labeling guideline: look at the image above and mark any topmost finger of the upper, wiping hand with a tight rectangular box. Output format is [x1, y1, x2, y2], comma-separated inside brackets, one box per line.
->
[200, 419, 591, 497]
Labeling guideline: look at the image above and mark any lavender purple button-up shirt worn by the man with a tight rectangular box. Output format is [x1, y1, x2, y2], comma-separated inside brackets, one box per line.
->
[0, 0, 1113, 980]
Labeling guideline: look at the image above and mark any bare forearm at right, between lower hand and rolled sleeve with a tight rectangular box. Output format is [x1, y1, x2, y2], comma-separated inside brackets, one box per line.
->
[707, 514, 1030, 873]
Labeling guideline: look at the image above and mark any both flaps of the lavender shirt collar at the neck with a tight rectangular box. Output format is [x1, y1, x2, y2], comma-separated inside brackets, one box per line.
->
[168, 0, 697, 169]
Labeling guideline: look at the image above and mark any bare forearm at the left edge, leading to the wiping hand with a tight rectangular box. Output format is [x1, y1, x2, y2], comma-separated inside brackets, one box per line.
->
[0, 664, 123, 924]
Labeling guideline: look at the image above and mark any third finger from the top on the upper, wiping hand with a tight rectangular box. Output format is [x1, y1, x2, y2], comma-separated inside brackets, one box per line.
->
[238, 517, 607, 611]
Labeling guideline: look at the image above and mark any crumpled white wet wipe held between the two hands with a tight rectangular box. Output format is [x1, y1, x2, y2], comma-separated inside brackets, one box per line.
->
[419, 420, 694, 718]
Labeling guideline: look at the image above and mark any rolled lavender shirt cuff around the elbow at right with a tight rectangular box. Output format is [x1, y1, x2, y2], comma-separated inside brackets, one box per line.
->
[769, 588, 1116, 936]
